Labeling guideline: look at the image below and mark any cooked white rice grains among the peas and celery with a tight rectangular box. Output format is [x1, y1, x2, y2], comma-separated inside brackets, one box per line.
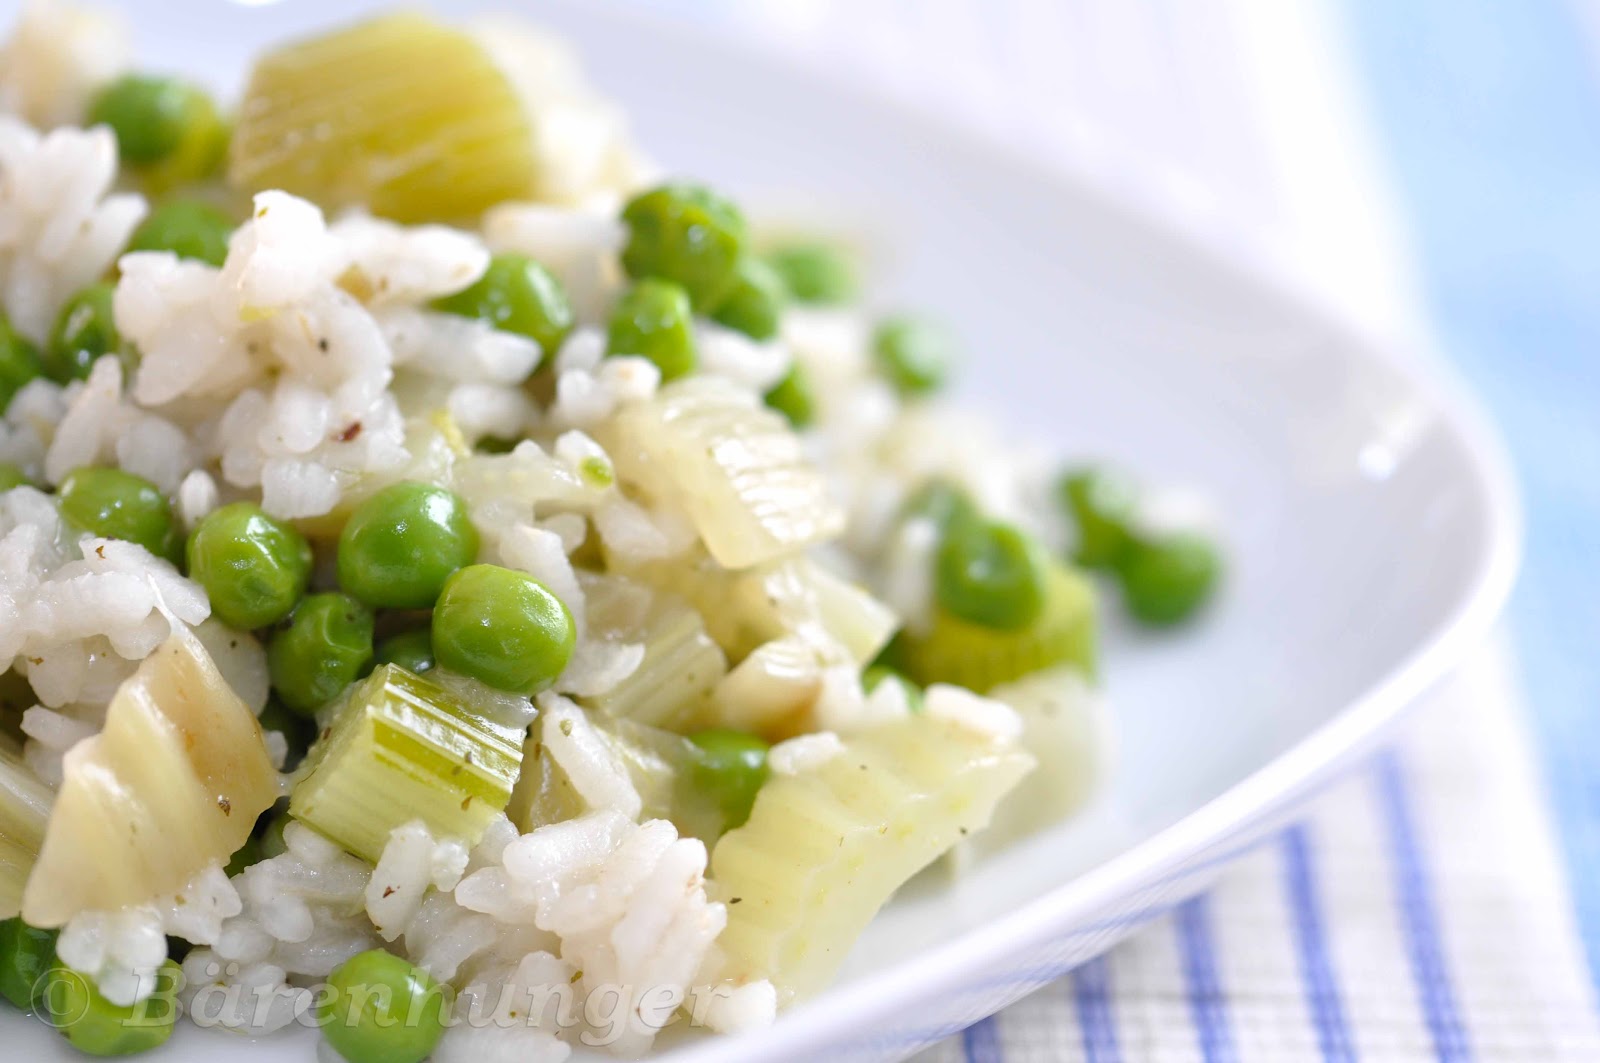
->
[0, 3, 1120, 1063]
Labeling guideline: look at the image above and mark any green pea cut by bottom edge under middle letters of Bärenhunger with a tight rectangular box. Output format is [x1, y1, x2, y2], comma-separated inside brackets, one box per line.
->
[317, 949, 451, 1063]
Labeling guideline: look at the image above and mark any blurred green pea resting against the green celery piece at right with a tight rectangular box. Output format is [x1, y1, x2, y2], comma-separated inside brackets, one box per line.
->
[934, 520, 1048, 631]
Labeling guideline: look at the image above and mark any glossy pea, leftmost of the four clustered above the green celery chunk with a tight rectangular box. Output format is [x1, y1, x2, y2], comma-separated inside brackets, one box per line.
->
[189, 503, 312, 631]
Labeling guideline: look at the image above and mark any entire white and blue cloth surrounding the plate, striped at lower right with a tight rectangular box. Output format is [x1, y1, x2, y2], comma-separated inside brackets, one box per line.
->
[614, 0, 1600, 1063]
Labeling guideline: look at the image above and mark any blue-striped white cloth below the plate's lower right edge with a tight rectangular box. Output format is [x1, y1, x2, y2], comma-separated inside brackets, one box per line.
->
[918, 642, 1600, 1063]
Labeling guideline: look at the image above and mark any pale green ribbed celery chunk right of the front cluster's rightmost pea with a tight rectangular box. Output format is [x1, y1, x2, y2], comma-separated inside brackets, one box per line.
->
[584, 596, 728, 730]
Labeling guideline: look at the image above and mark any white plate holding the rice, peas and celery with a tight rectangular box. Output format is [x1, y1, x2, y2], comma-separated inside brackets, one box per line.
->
[0, 0, 1518, 1063]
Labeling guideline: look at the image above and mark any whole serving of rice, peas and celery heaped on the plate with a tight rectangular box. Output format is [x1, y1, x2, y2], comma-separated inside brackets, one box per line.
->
[0, 3, 1219, 1063]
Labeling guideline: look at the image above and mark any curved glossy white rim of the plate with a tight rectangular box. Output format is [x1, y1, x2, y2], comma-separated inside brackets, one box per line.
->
[611, 10, 1525, 1063]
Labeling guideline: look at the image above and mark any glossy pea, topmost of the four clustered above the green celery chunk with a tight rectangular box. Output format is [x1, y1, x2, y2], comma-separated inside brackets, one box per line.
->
[338, 480, 478, 608]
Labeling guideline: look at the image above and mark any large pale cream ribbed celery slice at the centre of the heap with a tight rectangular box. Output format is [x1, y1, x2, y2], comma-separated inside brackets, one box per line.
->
[602, 378, 845, 568]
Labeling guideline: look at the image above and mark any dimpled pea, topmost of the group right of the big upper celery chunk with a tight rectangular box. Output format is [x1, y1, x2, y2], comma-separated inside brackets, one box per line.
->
[622, 183, 749, 307]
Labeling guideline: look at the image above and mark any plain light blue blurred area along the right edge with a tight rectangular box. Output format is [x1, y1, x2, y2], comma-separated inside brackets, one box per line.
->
[1342, 0, 1600, 1005]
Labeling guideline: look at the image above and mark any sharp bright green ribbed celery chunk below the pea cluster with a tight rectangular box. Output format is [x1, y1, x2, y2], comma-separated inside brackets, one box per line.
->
[290, 664, 523, 863]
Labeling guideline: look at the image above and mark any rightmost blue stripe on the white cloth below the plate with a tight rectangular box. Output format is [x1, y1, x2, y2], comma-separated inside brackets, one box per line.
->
[1374, 749, 1472, 1063]
